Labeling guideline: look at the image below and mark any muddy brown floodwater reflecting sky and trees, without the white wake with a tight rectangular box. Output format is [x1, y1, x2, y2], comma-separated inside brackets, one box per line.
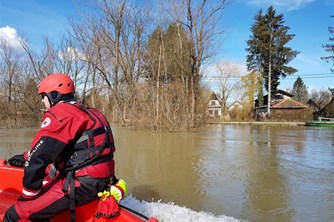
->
[0, 125, 334, 221]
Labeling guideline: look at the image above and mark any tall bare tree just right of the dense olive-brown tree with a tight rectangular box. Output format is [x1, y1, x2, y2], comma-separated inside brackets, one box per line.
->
[167, 0, 226, 126]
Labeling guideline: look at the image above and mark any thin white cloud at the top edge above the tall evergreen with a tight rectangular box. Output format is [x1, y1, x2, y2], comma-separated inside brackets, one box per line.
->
[248, 0, 315, 11]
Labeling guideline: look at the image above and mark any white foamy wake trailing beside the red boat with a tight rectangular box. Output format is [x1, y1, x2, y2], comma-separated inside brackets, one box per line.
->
[121, 195, 240, 222]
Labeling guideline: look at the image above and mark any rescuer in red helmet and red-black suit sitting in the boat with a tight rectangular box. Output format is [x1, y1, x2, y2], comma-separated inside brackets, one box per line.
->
[4, 73, 126, 222]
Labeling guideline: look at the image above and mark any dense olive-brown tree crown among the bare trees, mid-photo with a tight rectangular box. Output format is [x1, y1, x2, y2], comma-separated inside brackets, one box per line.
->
[144, 22, 193, 84]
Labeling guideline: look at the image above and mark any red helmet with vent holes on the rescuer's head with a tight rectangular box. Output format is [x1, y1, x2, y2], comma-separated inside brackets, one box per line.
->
[38, 73, 75, 95]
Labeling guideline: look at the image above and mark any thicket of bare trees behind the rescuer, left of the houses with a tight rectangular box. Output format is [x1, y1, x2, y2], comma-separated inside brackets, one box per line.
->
[0, 0, 225, 130]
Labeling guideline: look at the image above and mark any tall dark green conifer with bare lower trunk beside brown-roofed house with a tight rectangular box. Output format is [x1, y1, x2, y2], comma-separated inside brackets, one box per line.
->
[246, 6, 299, 113]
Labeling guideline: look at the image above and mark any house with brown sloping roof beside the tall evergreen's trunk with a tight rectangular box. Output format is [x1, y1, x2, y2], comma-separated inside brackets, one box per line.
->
[254, 90, 312, 121]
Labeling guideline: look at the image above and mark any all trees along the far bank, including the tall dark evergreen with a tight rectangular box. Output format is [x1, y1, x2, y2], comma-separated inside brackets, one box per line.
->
[0, 0, 331, 130]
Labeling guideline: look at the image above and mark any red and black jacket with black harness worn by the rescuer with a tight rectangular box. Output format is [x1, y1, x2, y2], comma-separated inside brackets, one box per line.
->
[23, 102, 115, 199]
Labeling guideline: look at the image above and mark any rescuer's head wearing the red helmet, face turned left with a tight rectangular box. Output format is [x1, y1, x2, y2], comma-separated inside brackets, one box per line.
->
[38, 73, 75, 109]
